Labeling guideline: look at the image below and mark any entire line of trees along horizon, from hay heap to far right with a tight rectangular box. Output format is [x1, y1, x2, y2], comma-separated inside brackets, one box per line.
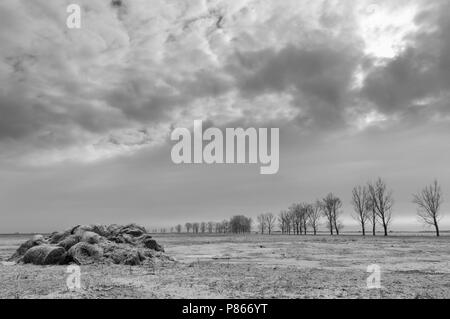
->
[160, 178, 443, 236]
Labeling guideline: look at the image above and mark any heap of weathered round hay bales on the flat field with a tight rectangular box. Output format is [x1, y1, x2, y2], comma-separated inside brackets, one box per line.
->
[9, 224, 171, 265]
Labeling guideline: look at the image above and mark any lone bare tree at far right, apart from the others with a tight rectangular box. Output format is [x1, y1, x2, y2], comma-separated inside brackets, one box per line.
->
[413, 180, 443, 236]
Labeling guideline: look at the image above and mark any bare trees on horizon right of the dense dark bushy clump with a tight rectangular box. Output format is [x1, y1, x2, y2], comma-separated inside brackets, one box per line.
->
[268, 178, 443, 236]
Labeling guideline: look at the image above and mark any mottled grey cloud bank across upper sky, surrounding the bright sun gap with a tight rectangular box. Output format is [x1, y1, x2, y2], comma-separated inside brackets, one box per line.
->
[0, 1, 450, 166]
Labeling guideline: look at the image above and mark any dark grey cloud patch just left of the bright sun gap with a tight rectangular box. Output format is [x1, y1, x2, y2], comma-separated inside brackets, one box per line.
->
[228, 38, 362, 127]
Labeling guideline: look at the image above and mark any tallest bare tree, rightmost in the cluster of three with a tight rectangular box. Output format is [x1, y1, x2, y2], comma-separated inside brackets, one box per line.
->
[369, 178, 394, 236]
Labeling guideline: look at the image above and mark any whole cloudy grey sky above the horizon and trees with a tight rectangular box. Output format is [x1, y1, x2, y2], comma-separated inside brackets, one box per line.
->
[0, 0, 450, 232]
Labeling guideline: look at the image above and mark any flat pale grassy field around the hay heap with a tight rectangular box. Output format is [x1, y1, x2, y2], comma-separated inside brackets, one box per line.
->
[0, 234, 450, 298]
